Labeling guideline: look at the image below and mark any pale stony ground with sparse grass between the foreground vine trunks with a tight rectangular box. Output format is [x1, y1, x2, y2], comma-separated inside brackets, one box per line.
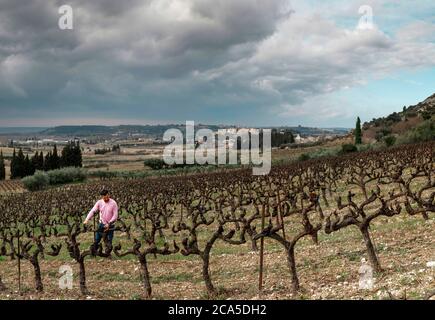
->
[0, 215, 435, 299]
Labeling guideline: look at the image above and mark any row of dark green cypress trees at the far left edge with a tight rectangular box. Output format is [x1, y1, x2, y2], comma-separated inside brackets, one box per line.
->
[0, 141, 83, 180]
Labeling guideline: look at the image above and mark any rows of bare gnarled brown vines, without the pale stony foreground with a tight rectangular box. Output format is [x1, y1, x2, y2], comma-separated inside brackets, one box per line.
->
[0, 142, 435, 299]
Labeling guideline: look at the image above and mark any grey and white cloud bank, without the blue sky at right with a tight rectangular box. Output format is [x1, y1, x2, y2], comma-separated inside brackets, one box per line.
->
[0, 0, 435, 125]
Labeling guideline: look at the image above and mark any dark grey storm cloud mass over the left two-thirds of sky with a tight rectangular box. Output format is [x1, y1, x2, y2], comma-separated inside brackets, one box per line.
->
[0, 0, 288, 122]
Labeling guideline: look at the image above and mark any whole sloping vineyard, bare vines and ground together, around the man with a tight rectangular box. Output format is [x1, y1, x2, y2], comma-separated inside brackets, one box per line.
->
[0, 142, 435, 299]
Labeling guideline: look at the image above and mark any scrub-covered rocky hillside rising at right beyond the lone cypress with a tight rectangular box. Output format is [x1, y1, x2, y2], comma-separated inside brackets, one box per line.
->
[363, 94, 435, 141]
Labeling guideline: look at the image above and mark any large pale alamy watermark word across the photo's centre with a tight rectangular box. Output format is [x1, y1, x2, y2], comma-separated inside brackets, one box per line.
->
[163, 121, 271, 175]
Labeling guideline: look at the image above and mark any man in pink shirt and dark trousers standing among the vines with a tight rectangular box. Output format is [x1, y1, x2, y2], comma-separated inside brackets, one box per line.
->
[84, 190, 118, 255]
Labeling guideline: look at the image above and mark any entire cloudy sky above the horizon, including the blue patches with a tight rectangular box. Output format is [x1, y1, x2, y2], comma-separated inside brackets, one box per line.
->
[0, 0, 435, 127]
